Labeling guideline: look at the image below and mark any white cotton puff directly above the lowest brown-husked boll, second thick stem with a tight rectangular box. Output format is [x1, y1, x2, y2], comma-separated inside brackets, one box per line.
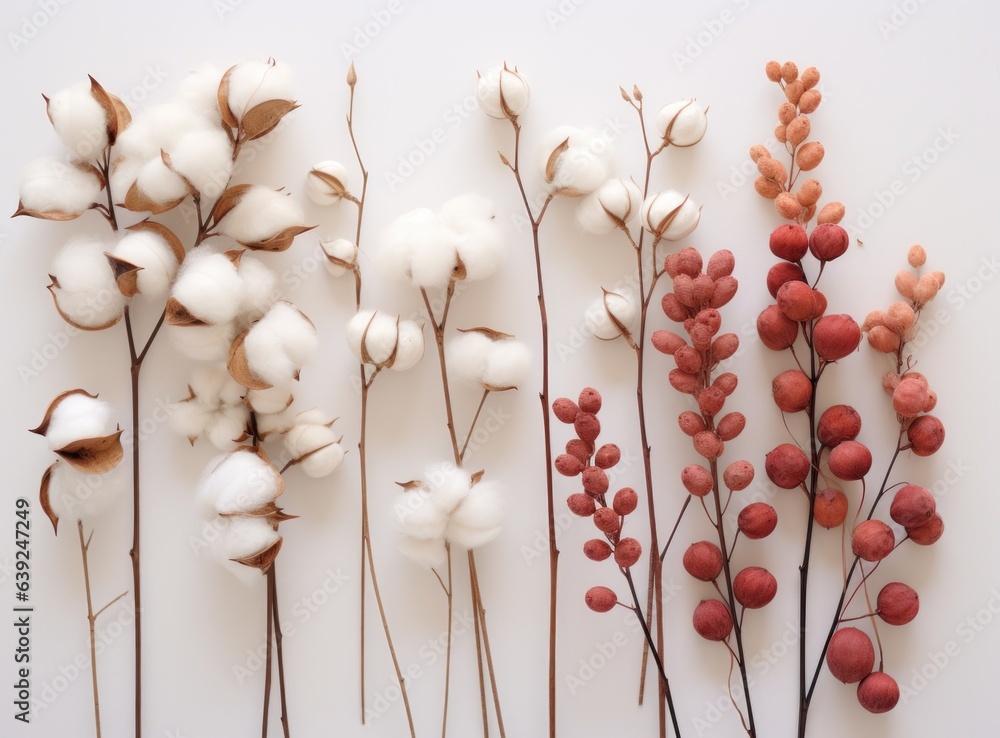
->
[198, 447, 284, 515]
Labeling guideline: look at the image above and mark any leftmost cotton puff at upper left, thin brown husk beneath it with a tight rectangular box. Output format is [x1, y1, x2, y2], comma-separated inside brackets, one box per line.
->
[18, 156, 101, 215]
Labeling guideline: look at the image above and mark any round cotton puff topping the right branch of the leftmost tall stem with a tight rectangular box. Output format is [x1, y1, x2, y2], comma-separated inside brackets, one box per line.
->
[171, 247, 243, 324]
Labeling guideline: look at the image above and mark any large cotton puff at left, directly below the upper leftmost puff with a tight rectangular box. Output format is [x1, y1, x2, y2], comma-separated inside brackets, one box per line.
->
[50, 237, 127, 329]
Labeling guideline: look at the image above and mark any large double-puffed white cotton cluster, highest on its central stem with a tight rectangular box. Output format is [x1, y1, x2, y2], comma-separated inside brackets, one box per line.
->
[376, 194, 507, 289]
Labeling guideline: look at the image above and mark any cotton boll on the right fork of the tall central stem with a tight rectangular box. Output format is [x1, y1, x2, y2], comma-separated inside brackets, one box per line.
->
[540, 126, 611, 197]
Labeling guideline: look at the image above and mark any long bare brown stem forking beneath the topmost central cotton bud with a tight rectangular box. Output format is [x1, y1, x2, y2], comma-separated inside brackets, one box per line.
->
[500, 119, 559, 738]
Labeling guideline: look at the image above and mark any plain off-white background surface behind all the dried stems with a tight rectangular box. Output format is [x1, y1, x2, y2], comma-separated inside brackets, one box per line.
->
[0, 0, 1000, 738]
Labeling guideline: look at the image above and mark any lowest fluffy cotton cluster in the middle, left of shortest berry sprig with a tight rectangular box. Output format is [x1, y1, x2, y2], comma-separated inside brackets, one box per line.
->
[395, 465, 503, 567]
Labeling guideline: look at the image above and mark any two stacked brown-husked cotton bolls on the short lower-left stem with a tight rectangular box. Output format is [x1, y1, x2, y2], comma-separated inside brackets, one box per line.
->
[32, 389, 125, 530]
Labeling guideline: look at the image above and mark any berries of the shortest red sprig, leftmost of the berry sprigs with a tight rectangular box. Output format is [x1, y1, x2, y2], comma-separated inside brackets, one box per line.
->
[552, 387, 642, 612]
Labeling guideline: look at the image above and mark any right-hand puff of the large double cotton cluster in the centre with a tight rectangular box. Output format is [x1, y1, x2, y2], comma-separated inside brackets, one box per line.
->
[440, 193, 507, 281]
